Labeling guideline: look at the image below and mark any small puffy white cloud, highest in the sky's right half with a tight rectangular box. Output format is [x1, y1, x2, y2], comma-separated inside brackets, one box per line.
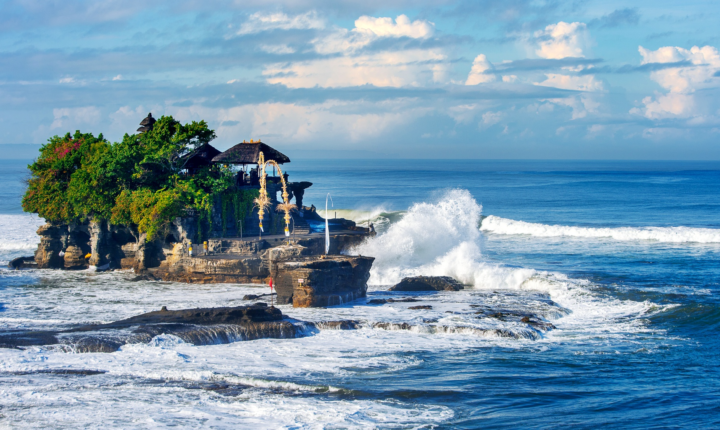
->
[534, 21, 590, 59]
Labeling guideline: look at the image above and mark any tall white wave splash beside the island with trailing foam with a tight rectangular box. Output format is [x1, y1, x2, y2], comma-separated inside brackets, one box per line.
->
[354, 190, 656, 332]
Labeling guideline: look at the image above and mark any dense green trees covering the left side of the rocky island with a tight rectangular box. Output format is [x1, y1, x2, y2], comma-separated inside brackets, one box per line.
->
[23, 116, 237, 239]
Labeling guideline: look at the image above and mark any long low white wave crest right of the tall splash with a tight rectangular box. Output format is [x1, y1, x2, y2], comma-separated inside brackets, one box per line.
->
[480, 215, 720, 243]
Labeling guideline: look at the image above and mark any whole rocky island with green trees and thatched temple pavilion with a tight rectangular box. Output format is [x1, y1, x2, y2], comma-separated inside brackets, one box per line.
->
[18, 114, 374, 307]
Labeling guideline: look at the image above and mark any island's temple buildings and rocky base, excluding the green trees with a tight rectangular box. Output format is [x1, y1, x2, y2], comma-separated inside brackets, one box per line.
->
[23, 114, 374, 307]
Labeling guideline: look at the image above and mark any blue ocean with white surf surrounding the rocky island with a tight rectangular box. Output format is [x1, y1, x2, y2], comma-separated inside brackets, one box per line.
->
[0, 160, 720, 429]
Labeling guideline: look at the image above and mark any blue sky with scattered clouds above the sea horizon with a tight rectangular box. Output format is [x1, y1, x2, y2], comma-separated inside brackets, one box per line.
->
[0, 0, 720, 160]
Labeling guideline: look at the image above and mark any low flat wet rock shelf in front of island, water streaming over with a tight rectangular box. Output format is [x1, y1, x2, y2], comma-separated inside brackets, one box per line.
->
[0, 287, 569, 353]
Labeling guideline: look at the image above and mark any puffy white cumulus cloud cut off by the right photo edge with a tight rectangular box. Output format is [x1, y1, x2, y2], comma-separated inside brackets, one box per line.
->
[630, 46, 720, 120]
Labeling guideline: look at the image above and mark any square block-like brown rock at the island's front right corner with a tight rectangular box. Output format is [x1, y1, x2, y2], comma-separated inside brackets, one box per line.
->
[273, 255, 375, 308]
